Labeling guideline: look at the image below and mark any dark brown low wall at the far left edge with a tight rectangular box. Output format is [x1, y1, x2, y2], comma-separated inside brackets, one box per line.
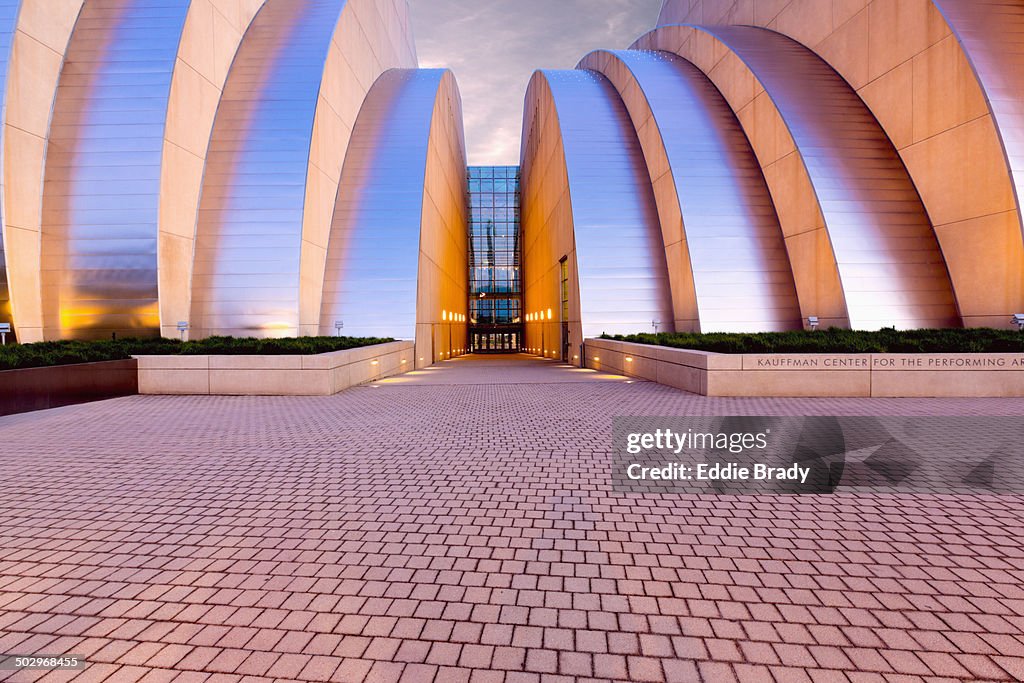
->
[0, 360, 138, 415]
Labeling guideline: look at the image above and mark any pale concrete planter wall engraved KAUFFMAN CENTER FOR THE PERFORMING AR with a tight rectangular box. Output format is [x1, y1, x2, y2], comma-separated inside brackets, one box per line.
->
[586, 339, 1024, 397]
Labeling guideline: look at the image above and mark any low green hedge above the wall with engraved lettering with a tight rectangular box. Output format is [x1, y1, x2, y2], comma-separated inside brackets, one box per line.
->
[601, 328, 1024, 353]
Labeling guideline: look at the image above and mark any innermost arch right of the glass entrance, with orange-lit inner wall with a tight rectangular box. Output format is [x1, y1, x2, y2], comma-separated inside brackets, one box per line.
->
[520, 70, 674, 354]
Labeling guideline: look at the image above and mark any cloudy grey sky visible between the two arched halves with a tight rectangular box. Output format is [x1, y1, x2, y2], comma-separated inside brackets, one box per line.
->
[410, 0, 662, 165]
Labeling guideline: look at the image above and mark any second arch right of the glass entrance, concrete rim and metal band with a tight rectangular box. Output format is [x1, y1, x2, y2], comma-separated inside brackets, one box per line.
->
[580, 50, 801, 332]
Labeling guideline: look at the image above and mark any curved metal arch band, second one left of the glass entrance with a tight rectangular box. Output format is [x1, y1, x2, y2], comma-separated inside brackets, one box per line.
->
[190, 0, 345, 337]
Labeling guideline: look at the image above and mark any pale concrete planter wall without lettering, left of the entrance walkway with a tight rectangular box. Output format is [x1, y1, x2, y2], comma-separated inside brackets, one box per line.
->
[136, 341, 416, 396]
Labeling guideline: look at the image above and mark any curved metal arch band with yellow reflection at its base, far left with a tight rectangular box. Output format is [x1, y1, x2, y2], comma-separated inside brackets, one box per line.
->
[40, 0, 188, 338]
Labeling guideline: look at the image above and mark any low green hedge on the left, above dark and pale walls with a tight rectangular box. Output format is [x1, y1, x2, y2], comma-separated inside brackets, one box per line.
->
[0, 337, 394, 370]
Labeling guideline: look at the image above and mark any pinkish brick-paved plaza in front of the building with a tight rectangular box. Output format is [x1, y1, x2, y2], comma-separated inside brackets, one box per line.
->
[0, 357, 1024, 683]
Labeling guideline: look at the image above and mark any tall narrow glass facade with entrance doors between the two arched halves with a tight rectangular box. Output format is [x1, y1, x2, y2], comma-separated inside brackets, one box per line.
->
[468, 166, 522, 353]
